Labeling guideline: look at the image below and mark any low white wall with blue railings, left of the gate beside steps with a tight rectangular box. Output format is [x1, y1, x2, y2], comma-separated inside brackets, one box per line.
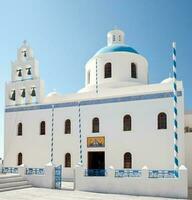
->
[0, 163, 55, 188]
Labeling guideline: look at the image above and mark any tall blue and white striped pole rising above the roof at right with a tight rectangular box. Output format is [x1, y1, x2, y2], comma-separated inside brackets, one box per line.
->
[173, 42, 179, 177]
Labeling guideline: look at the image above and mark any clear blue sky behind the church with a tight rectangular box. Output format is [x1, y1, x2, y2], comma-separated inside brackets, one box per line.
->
[0, 0, 192, 157]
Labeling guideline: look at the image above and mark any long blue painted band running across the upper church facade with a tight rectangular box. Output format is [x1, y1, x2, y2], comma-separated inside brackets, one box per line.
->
[5, 91, 182, 112]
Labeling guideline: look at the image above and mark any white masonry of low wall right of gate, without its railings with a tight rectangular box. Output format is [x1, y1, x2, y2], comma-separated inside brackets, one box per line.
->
[75, 167, 188, 198]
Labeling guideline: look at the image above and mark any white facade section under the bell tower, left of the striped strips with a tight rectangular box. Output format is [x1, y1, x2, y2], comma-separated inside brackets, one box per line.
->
[4, 110, 51, 167]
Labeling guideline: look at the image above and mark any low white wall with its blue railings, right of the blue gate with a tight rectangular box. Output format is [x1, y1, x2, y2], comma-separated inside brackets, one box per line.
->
[75, 166, 188, 198]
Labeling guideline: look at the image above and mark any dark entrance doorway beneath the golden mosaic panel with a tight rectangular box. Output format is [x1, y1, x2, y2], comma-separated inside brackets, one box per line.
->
[88, 151, 105, 176]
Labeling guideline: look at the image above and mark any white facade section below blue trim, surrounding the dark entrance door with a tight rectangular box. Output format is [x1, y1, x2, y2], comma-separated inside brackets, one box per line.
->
[81, 94, 184, 169]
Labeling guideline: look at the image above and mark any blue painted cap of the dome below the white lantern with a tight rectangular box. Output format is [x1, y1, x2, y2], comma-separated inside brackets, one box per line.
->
[95, 44, 139, 55]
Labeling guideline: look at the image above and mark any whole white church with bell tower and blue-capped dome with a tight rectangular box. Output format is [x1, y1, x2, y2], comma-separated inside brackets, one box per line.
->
[4, 30, 192, 186]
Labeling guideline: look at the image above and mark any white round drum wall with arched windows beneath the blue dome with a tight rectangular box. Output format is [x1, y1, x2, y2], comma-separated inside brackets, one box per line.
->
[80, 52, 148, 92]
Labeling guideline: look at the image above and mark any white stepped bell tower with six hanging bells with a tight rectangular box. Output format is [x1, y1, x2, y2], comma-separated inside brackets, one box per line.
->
[5, 41, 44, 106]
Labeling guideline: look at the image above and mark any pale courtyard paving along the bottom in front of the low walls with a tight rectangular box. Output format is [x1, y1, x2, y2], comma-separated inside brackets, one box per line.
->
[0, 188, 188, 200]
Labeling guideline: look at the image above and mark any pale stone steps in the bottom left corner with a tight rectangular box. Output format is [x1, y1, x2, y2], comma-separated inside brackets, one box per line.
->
[0, 174, 32, 192]
